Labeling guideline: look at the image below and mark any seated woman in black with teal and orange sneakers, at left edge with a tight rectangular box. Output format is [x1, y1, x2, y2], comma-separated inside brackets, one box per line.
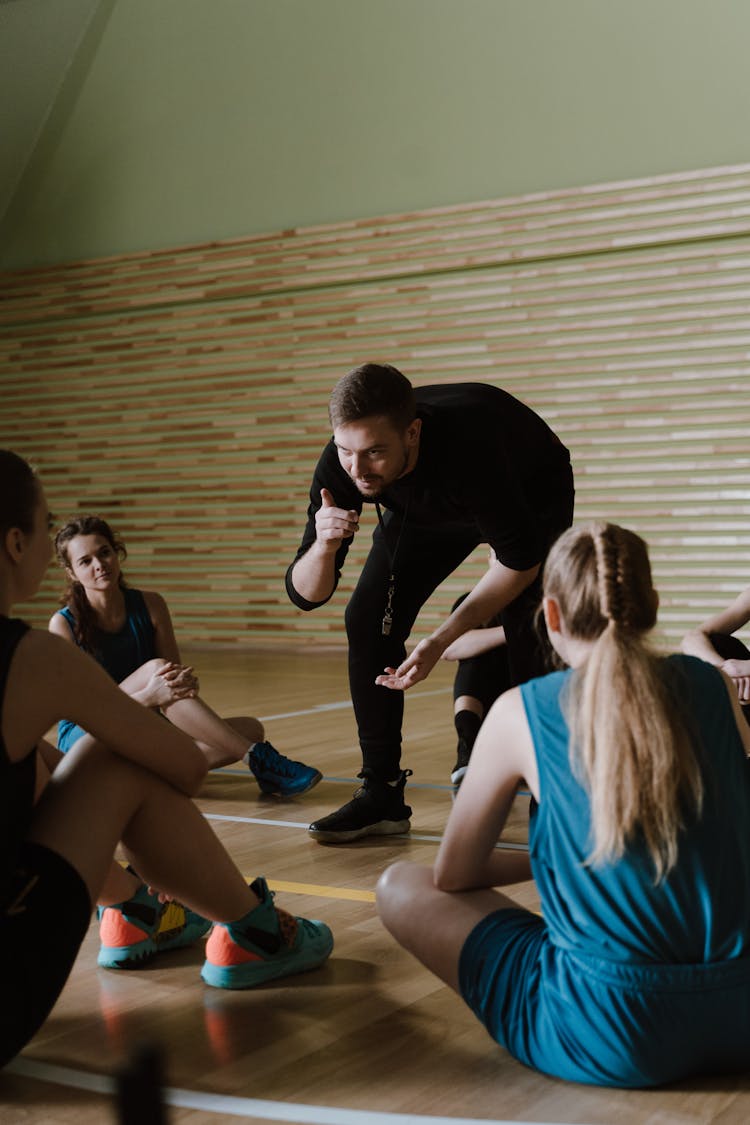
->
[0, 450, 333, 1065]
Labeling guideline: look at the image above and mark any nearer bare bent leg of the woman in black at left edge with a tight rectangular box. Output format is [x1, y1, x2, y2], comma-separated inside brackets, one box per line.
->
[29, 739, 259, 921]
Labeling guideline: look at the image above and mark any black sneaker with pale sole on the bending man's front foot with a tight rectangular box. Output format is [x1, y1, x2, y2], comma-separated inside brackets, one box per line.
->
[308, 770, 412, 844]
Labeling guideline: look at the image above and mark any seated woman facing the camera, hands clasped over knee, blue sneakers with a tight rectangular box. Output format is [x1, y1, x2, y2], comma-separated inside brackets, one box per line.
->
[49, 515, 322, 797]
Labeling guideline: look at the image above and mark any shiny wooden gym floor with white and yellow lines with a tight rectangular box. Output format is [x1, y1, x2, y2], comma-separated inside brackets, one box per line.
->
[0, 653, 750, 1125]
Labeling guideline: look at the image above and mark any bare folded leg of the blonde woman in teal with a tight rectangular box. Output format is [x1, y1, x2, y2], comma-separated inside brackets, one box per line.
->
[377, 861, 526, 992]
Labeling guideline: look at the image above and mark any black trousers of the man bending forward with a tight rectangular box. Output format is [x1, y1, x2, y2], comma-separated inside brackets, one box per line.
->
[345, 488, 572, 781]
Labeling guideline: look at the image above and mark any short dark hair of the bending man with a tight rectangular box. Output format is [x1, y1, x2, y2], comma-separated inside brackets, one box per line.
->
[328, 363, 417, 433]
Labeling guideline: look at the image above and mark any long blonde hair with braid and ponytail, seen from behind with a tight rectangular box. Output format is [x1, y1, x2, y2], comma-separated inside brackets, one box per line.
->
[544, 523, 703, 882]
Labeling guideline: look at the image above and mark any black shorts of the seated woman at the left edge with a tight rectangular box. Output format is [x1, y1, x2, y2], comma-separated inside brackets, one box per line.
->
[0, 843, 91, 1067]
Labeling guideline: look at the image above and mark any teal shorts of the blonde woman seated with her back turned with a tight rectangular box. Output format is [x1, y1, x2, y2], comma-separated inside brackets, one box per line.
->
[459, 908, 750, 1087]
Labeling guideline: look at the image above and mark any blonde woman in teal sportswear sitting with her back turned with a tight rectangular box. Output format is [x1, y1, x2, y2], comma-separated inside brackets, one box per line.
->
[378, 523, 750, 1087]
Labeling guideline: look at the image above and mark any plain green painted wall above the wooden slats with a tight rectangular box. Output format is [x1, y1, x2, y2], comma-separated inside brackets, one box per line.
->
[0, 0, 750, 268]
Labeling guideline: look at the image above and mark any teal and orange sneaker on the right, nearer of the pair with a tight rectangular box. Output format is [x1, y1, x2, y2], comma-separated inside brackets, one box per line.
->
[200, 878, 333, 989]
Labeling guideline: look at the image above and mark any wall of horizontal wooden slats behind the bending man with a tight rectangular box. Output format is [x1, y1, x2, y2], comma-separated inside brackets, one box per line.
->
[0, 165, 750, 645]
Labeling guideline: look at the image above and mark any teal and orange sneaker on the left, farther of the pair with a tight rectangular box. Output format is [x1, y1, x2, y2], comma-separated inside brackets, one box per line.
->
[97, 883, 214, 969]
